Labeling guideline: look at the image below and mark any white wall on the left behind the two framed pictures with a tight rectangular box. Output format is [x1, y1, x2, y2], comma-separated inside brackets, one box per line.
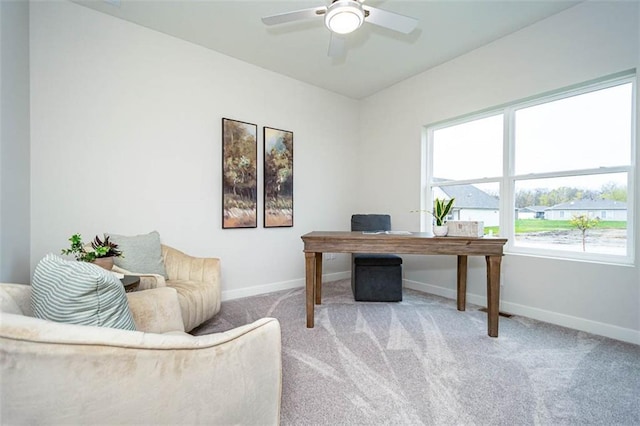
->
[31, 1, 359, 298]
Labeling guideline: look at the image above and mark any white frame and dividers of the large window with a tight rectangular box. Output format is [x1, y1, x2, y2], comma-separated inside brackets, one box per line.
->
[420, 72, 638, 265]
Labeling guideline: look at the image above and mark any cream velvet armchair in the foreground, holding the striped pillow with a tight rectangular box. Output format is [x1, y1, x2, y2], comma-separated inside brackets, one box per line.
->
[0, 282, 282, 425]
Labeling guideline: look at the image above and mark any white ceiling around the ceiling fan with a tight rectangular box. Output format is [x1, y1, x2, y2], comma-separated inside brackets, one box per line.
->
[73, 0, 581, 99]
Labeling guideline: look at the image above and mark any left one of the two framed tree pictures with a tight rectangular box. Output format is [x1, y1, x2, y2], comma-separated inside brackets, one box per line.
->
[222, 118, 258, 229]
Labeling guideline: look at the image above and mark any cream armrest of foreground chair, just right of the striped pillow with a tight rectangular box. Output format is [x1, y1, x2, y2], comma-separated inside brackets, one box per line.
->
[127, 287, 184, 333]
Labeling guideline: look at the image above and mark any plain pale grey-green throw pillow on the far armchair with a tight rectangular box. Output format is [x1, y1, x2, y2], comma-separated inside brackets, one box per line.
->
[107, 231, 169, 279]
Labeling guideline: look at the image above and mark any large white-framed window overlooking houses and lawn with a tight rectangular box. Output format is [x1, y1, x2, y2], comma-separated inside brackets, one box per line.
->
[424, 76, 636, 263]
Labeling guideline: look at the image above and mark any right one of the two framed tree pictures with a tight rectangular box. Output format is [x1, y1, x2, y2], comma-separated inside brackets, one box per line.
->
[263, 127, 293, 228]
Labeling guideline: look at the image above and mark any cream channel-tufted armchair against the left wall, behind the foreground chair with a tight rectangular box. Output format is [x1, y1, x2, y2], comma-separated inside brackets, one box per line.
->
[113, 244, 221, 331]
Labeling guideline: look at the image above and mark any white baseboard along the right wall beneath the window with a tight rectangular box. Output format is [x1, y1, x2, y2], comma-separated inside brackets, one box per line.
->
[403, 279, 640, 345]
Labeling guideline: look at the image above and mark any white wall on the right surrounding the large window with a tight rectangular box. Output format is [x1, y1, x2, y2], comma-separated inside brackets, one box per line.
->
[359, 2, 640, 343]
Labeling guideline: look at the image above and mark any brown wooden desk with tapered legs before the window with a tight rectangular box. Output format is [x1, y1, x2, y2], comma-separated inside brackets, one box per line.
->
[302, 232, 507, 337]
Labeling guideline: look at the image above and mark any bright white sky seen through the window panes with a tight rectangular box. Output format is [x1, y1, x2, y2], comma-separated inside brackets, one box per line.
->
[433, 83, 633, 189]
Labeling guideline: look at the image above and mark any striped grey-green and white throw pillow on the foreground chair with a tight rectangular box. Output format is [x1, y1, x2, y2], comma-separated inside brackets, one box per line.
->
[31, 254, 136, 330]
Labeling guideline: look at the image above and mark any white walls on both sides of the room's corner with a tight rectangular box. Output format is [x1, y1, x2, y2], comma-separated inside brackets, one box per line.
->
[23, 2, 640, 342]
